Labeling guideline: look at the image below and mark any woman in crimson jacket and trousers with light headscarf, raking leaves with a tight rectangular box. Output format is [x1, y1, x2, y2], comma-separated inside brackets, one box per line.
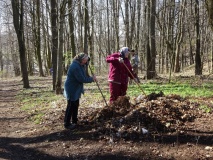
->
[106, 47, 135, 103]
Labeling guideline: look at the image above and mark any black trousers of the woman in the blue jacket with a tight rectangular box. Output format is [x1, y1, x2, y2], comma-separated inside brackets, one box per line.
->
[64, 99, 79, 126]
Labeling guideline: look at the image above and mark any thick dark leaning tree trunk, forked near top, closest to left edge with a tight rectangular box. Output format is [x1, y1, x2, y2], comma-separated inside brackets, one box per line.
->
[11, 0, 30, 88]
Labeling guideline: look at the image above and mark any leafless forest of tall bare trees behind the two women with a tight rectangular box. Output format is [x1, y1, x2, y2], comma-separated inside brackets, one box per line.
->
[0, 0, 213, 91]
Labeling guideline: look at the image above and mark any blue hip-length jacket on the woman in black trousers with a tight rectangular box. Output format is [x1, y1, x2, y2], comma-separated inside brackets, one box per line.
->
[64, 60, 93, 101]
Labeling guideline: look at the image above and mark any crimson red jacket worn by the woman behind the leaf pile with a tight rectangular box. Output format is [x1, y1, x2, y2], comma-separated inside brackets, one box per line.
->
[106, 52, 134, 84]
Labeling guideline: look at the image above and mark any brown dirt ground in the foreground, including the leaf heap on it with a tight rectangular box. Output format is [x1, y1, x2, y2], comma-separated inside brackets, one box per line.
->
[0, 77, 213, 160]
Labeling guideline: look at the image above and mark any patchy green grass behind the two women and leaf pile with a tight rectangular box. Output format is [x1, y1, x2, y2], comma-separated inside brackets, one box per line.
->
[16, 80, 213, 124]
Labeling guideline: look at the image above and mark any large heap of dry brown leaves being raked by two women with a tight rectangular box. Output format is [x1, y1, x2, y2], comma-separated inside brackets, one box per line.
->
[81, 92, 203, 140]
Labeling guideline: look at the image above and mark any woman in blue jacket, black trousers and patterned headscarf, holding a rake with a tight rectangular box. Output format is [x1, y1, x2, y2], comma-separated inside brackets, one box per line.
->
[64, 53, 96, 129]
